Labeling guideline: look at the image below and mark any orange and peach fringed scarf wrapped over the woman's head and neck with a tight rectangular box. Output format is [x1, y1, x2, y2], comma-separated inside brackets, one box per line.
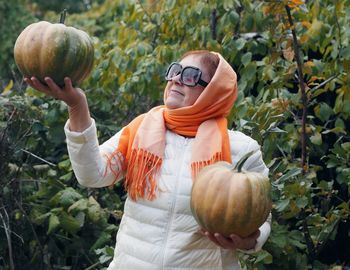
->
[108, 52, 237, 200]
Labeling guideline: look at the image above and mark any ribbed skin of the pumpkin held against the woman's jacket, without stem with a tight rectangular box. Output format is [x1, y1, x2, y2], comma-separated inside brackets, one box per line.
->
[191, 161, 272, 237]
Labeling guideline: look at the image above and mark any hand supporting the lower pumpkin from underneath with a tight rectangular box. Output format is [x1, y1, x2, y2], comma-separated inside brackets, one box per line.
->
[200, 229, 260, 250]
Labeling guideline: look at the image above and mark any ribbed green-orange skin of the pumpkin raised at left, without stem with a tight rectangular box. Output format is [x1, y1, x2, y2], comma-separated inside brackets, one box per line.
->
[14, 21, 94, 86]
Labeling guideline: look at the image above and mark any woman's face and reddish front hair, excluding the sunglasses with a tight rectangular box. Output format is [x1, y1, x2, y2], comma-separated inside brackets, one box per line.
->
[165, 55, 211, 109]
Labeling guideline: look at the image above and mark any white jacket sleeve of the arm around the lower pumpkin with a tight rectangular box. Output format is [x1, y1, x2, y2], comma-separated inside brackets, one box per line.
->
[230, 131, 272, 254]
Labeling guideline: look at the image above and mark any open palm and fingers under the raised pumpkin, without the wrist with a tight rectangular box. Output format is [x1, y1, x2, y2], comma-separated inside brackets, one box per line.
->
[24, 77, 86, 108]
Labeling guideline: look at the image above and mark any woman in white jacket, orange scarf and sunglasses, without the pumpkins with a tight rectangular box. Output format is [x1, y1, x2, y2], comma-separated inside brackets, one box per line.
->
[25, 51, 270, 270]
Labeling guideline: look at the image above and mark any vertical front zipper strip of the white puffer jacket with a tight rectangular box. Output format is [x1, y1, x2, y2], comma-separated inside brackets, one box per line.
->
[162, 138, 189, 270]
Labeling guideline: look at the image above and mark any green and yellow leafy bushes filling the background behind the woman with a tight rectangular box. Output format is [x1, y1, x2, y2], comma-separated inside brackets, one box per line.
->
[0, 0, 350, 270]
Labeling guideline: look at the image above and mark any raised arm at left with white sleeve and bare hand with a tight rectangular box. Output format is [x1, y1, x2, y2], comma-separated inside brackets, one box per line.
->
[24, 77, 122, 187]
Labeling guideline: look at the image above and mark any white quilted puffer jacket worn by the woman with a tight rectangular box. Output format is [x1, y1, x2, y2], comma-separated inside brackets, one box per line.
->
[65, 121, 270, 270]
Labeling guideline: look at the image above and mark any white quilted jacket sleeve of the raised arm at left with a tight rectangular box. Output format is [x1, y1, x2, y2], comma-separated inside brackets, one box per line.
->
[64, 119, 122, 187]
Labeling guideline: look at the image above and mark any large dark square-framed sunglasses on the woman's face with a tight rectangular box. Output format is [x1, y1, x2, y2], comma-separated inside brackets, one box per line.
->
[165, 62, 208, 87]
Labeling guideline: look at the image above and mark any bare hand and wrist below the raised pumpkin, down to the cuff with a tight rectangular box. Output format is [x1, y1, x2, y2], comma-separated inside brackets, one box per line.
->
[24, 77, 91, 132]
